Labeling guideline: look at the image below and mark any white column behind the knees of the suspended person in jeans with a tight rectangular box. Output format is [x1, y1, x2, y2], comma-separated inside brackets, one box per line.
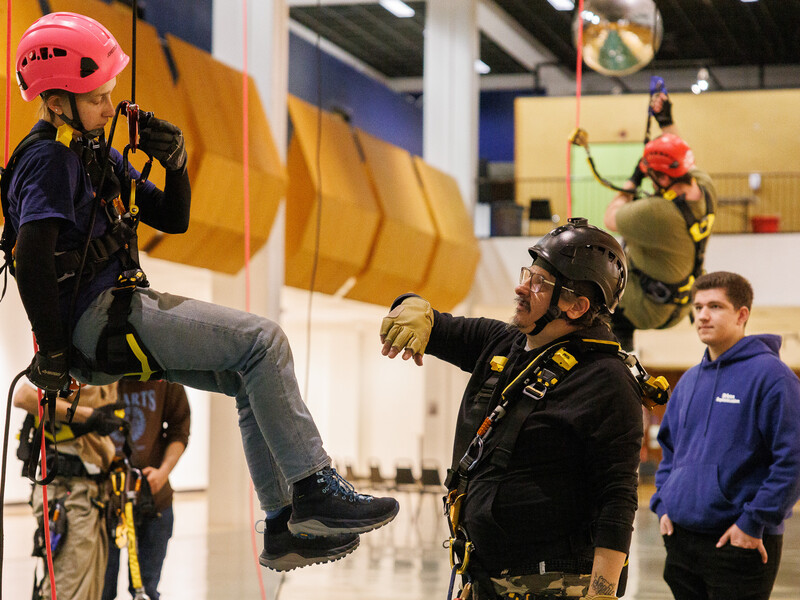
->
[208, 0, 289, 527]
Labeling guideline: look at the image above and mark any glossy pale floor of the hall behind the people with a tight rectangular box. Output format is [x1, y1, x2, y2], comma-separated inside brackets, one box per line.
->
[3, 488, 800, 600]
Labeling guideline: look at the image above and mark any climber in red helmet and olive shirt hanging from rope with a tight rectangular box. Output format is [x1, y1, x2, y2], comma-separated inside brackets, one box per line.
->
[604, 93, 717, 351]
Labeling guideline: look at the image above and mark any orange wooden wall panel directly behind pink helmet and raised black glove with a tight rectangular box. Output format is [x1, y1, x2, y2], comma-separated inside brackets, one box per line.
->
[50, 0, 194, 248]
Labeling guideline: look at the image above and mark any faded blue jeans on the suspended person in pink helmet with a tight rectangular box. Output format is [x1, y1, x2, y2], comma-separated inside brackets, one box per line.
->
[72, 288, 331, 511]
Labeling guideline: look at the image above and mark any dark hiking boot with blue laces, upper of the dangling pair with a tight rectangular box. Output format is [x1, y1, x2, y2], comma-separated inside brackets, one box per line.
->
[289, 467, 400, 535]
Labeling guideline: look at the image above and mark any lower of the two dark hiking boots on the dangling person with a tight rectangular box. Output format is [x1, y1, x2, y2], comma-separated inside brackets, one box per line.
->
[258, 510, 359, 571]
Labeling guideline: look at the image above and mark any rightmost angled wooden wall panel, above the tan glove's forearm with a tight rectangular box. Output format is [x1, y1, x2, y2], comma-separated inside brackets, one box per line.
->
[414, 156, 480, 311]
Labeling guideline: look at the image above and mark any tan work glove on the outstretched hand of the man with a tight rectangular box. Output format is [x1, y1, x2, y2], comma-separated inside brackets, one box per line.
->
[381, 296, 433, 365]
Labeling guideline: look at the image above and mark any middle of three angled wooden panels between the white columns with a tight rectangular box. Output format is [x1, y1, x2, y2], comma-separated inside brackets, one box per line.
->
[346, 130, 437, 305]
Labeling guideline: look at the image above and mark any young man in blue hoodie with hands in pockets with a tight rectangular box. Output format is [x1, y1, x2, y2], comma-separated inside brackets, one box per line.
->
[650, 271, 800, 600]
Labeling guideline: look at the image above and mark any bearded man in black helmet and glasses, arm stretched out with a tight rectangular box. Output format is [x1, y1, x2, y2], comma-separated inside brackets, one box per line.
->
[381, 219, 642, 600]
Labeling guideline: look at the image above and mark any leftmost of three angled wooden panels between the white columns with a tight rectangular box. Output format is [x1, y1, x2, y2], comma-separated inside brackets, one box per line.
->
[285, 95, 381, 294]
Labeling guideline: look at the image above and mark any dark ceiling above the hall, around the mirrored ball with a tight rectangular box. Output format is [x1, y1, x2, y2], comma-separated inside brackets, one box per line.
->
[290, 0, 800, 88]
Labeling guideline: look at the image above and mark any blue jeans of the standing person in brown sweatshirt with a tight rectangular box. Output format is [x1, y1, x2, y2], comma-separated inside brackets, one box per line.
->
[103, 506, 174, 600]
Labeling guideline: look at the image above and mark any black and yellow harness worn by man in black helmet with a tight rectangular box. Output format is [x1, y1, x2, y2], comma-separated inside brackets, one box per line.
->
[443, 338, 669, 600]
